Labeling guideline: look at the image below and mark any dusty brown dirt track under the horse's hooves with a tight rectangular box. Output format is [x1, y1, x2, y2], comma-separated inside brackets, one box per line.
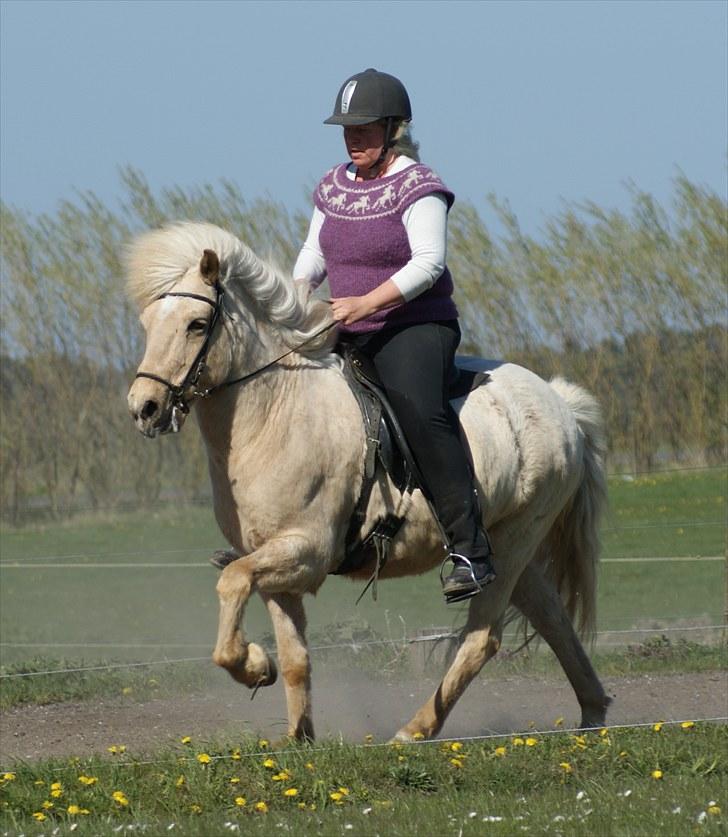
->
[0, 671, 728, 765]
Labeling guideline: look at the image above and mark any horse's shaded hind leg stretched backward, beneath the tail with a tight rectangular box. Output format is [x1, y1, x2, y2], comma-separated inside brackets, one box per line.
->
[511, 564, 611, 727]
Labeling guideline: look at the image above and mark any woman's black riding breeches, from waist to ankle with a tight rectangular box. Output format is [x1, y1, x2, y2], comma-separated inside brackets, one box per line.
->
[346, 320, 489, 558]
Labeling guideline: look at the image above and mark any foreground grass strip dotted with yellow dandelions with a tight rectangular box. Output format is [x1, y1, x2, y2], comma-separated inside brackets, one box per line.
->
[0, 724, 728, 837]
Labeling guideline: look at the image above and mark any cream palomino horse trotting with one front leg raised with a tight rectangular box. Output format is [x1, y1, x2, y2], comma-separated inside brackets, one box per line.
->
[128, 223, 609, 741]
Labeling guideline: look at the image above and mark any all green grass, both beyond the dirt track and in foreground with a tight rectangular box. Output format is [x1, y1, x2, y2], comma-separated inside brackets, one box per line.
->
[0, 471, 728, 837]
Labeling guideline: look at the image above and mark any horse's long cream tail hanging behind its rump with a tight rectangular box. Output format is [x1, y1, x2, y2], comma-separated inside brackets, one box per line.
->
[541, 378, 607, 638]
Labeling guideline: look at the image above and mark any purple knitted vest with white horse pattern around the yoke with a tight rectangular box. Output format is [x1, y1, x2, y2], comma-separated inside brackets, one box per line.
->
[313, 163, 458, 332]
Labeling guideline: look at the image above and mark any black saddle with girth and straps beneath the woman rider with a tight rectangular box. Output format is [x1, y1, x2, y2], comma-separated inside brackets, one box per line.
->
[331, 343, 498, 599]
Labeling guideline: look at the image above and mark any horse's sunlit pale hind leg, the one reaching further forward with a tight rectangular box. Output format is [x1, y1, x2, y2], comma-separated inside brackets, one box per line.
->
[395, 582, 505, 741]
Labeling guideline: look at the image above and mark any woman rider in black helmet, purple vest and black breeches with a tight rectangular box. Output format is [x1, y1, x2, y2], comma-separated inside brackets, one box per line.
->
[293, 69, 495, 602]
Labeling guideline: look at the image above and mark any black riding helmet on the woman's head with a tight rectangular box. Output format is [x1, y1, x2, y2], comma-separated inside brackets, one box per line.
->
[324, 68, 412, 125]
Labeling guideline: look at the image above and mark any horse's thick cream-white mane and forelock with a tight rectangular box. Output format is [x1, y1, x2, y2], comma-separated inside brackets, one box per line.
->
[126, 221, 336, 354]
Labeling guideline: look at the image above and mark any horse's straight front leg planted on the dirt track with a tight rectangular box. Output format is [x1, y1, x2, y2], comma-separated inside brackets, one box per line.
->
[263, 593, 314, 740]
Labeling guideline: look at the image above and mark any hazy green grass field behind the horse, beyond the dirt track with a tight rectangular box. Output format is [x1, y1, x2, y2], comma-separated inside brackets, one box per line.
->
[0, 470, 728, 663]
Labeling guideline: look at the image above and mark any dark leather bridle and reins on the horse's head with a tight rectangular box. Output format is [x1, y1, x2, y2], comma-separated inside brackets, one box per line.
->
[134, 282, 338, 424]
